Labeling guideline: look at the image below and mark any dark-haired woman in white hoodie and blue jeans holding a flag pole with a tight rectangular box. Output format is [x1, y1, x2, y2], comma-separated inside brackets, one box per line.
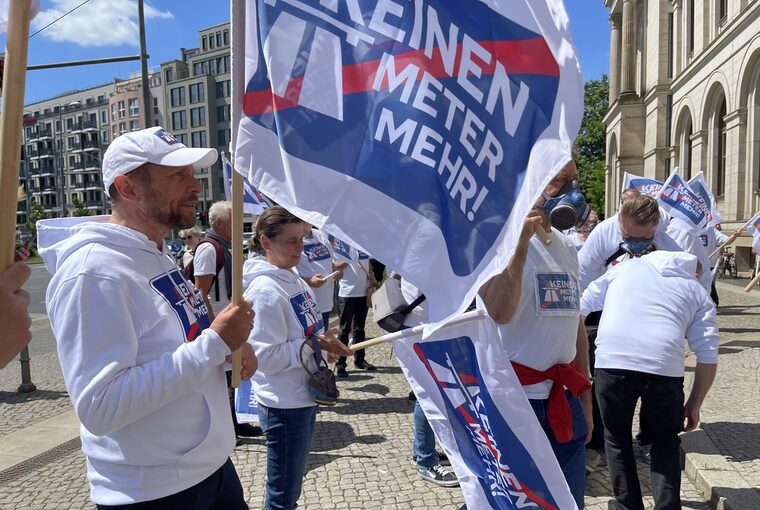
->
[243, 206, 351, 510]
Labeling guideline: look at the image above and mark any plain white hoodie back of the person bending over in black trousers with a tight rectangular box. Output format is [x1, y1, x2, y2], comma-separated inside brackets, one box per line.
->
[581, 251, 718, 377]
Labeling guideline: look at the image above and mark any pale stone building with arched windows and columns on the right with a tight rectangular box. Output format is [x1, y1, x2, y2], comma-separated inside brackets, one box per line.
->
[604, 0, 760, 270]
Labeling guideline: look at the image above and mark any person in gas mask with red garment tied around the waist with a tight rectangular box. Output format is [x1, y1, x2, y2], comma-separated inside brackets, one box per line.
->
[479, 161, 593, 509]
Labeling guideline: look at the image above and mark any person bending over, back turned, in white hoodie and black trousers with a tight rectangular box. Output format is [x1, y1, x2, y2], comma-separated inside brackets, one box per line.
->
[581, 250, 718, 510]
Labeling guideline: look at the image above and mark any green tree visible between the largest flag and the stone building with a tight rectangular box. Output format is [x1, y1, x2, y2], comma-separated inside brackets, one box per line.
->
[575, 74, 609, 214]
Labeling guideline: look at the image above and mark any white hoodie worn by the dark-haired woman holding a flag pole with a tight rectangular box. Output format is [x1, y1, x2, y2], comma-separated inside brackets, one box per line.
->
[243, 259, 324, 409]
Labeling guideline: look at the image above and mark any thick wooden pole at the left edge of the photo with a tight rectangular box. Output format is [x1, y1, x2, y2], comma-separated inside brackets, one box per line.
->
[0, 0, 32, 271]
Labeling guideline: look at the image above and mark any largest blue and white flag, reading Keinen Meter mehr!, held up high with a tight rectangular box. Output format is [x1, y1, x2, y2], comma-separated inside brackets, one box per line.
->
[232, 0, 583, 322]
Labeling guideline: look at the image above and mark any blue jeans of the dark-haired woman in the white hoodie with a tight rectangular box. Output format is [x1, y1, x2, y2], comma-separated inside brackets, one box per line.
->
[259, 404, 317, 510]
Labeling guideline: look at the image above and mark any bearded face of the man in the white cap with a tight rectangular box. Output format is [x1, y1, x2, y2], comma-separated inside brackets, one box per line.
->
[132, 163, 201, 229]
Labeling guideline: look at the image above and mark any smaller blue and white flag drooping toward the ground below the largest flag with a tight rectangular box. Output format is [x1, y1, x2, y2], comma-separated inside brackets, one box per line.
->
[393, 318, 577, 510]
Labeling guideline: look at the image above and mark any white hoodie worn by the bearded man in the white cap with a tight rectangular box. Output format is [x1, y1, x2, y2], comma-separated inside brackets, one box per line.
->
[37, 217, 235, 505]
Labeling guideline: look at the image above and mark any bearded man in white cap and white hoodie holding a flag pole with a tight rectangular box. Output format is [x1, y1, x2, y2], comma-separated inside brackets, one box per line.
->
[38, 127, 256, 509]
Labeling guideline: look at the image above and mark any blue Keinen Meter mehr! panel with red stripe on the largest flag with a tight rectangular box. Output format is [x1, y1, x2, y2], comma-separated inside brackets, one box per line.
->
[243, 0, 560, 276]
